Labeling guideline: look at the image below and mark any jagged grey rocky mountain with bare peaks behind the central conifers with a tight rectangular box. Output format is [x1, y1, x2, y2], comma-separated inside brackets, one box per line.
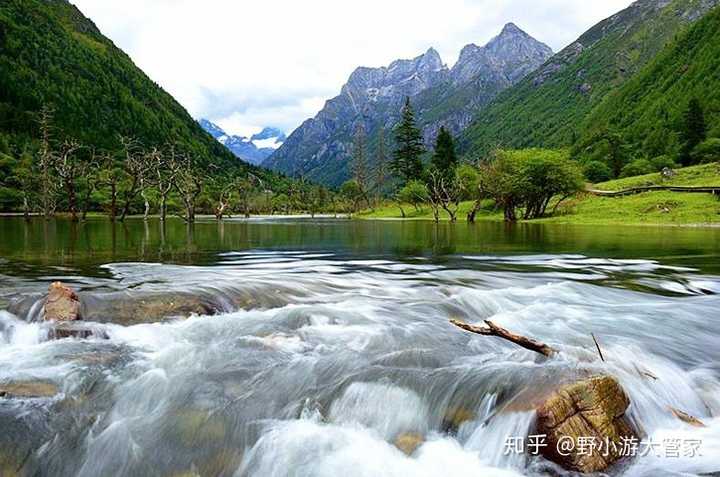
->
[263, 24, 552, 185]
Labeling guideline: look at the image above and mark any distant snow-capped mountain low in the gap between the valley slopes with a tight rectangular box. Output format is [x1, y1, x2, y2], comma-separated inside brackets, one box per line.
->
[199, 119, 286, 165]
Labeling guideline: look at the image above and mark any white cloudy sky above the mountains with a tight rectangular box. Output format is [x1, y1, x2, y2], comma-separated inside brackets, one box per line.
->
[71, 0, 631, 135]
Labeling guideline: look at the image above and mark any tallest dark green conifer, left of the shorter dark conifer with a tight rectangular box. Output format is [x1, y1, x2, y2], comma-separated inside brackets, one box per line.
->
[390, 98, 425, 185]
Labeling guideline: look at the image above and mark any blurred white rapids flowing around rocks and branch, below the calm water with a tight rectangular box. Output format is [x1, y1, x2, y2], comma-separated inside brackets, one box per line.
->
[0, 251, 720, 477]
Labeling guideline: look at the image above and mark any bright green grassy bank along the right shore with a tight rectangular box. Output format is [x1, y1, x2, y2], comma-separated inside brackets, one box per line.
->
[356, 164, 720, 225]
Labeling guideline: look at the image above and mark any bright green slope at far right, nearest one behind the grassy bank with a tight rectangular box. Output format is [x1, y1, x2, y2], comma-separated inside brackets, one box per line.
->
[579, 7, 720, 158]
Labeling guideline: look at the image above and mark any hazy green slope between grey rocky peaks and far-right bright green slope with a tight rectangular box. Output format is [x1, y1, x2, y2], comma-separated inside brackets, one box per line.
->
[460, 0, 718, 157]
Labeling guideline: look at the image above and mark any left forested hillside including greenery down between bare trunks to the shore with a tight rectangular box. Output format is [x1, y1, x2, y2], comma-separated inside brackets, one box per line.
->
[0, 0, 296, 211]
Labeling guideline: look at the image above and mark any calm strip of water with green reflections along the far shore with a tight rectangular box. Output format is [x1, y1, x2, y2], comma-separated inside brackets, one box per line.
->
[0, 218, 720, 276]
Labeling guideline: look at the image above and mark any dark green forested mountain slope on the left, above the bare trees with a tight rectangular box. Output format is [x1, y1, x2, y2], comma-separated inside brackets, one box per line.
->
[0, 0, 280, 182]
